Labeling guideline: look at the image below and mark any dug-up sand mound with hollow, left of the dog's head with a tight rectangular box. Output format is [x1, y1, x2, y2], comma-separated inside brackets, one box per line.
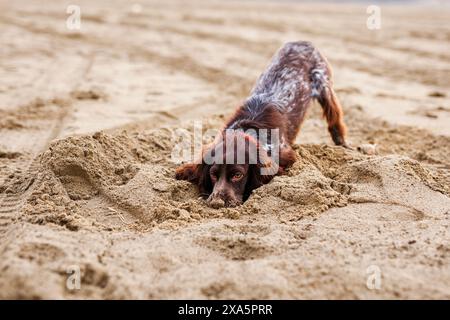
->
[25, 132, 197, 230]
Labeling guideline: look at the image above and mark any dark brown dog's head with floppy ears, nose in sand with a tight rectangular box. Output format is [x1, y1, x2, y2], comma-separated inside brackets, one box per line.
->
[176, 131, 295, 208]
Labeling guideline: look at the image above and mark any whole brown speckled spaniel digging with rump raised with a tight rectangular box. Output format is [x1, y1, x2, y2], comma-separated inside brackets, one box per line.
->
[176, 41, 348, 208]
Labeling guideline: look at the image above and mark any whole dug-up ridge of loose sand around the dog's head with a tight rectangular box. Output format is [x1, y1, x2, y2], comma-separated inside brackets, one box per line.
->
[18, 130, 449, 230]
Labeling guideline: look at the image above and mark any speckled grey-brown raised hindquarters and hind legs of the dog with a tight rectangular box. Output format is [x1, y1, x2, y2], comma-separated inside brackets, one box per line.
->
[247, 41, 345, 145]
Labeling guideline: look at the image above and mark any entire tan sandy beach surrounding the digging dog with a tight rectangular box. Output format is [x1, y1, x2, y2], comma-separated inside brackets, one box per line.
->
[0, 1, 450, 299]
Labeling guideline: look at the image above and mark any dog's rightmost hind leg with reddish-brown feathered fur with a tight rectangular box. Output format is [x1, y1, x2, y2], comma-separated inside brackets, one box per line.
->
[311, 54, 347, 146]
